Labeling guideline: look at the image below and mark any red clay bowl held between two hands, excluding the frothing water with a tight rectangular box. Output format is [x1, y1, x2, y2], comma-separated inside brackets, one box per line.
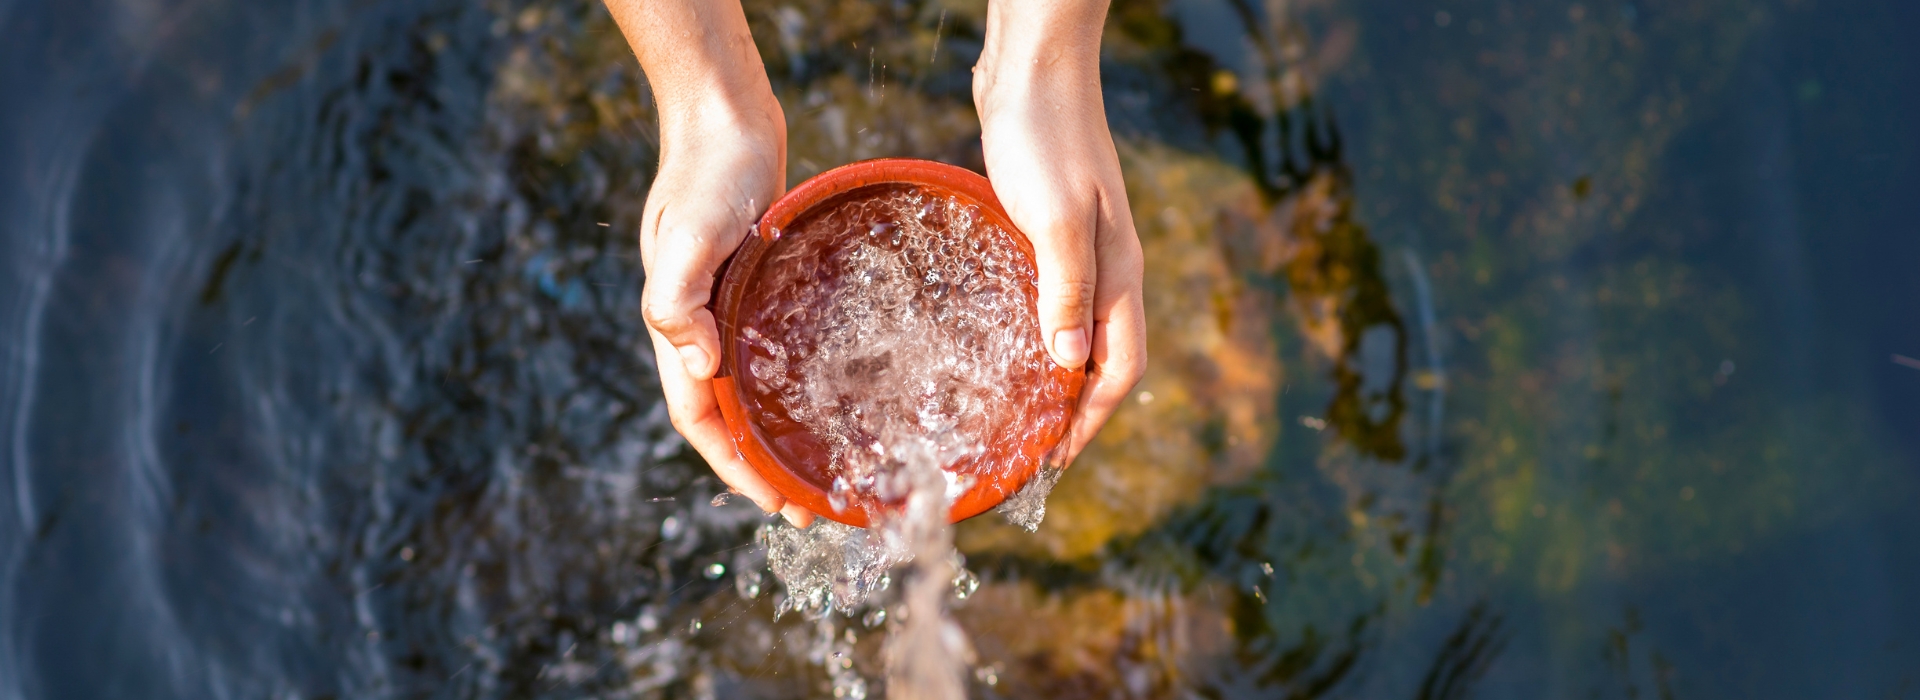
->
[712, 159, 1087, 527]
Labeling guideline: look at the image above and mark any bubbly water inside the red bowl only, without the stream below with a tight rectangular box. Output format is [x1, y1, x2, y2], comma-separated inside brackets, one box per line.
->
[743, 188, 1071, 508]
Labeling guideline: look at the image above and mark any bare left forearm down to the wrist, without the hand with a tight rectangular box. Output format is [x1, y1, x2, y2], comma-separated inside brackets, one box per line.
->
[607, 0, 785, 144]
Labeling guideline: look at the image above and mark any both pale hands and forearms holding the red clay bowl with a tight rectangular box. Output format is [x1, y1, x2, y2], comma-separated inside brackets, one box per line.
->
[607, 0, 1146, 527]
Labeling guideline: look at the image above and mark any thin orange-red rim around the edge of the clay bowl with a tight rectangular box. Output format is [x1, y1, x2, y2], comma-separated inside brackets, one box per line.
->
[708, 157, 1087, 527]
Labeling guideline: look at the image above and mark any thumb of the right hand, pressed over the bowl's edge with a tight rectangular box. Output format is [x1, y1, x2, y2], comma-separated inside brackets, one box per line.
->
[1002, 187, 1098, 370]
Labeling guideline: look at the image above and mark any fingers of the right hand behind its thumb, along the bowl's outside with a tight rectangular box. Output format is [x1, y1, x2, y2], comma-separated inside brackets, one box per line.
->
[1068, 211, 1146, 462]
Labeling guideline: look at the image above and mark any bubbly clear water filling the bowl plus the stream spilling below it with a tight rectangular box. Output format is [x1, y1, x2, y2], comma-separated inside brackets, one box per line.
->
[743, 188, 1069, 698]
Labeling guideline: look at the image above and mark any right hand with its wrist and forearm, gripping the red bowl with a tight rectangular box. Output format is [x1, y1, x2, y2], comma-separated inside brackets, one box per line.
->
[973, 0, 1146, 462]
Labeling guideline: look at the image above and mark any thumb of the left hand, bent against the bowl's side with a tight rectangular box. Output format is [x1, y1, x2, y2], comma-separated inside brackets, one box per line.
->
[639, 215, 739, 380]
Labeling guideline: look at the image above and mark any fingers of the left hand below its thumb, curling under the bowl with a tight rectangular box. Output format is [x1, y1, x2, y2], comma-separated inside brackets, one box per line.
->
[649, 332, 787, 512]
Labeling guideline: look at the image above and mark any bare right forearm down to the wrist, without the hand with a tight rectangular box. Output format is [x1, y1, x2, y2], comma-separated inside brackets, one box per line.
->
[973, 0, 1108, 111]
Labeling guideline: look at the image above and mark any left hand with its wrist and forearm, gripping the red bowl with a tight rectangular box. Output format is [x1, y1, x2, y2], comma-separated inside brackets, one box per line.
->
[607, 0, 814, 527]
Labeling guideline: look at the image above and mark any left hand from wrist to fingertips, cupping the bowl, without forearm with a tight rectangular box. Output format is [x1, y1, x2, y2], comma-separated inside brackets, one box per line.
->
[639, 94, 814, 527]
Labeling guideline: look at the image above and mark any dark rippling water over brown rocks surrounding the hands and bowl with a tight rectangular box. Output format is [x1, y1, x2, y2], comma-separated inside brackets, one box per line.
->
[0, 0, 1920, 698]
